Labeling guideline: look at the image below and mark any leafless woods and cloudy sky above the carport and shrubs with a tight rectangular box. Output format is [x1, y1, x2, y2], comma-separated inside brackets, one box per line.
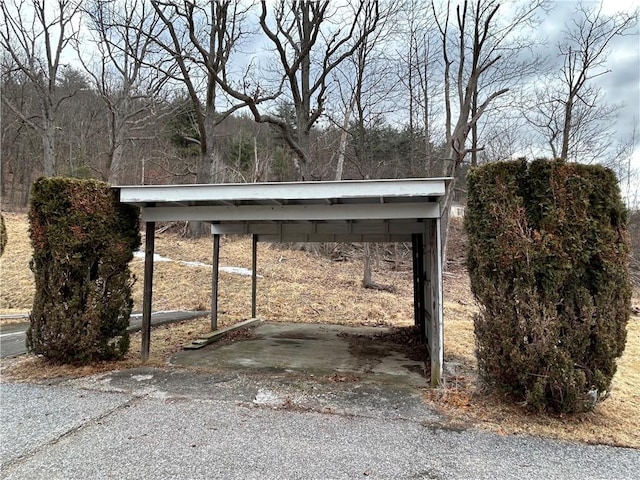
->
[0, 0, 638, 214]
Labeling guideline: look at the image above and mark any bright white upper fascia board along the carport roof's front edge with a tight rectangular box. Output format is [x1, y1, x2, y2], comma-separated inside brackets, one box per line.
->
[115, 178, 447, 205]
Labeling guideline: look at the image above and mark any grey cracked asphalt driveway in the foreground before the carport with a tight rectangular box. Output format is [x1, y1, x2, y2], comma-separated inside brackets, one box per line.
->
[0, 369, 640, 480]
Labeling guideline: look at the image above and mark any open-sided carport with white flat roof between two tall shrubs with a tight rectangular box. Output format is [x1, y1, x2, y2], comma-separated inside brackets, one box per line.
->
[114, 178, 450, 386]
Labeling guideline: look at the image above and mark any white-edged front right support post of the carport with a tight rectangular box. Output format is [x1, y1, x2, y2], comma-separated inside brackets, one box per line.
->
[428, 218, 444, 387]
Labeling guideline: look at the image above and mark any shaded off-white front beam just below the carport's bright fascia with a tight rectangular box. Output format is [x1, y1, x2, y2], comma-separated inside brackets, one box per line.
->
[142, 202, 440, 222]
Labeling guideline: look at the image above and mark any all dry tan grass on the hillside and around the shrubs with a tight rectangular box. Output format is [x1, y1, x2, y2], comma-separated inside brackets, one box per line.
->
[0, 213, 640, 448]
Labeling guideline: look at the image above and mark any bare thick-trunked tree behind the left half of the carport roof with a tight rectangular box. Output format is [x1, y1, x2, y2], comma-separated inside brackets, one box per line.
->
[146, 0, 272, 235]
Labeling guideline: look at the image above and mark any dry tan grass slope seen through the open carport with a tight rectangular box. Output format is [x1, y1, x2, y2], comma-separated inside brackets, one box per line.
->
[127, 234, 413, 325]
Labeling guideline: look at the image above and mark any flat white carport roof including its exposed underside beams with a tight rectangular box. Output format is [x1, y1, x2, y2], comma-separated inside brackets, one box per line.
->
[116, 178, 450, 241]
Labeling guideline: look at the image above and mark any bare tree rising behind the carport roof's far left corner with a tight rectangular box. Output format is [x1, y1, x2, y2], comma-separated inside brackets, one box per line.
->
[76, 0, 173, 183]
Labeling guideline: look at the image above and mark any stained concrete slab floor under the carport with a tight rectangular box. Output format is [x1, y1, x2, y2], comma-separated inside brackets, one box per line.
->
[170, 321, 428, 387]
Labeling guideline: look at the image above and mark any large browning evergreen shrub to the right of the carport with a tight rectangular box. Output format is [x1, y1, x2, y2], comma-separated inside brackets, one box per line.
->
[465, 160, 631, 412]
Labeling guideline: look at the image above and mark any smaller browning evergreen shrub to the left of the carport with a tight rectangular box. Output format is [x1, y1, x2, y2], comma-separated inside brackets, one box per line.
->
[27, 177, 140, 364]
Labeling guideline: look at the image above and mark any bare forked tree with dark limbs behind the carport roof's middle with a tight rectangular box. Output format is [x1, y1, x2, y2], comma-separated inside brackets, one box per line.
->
[218, 0, 379, 180]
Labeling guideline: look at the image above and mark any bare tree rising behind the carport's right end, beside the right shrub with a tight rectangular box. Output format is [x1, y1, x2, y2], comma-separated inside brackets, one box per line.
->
[431, 0, 544, 258]
